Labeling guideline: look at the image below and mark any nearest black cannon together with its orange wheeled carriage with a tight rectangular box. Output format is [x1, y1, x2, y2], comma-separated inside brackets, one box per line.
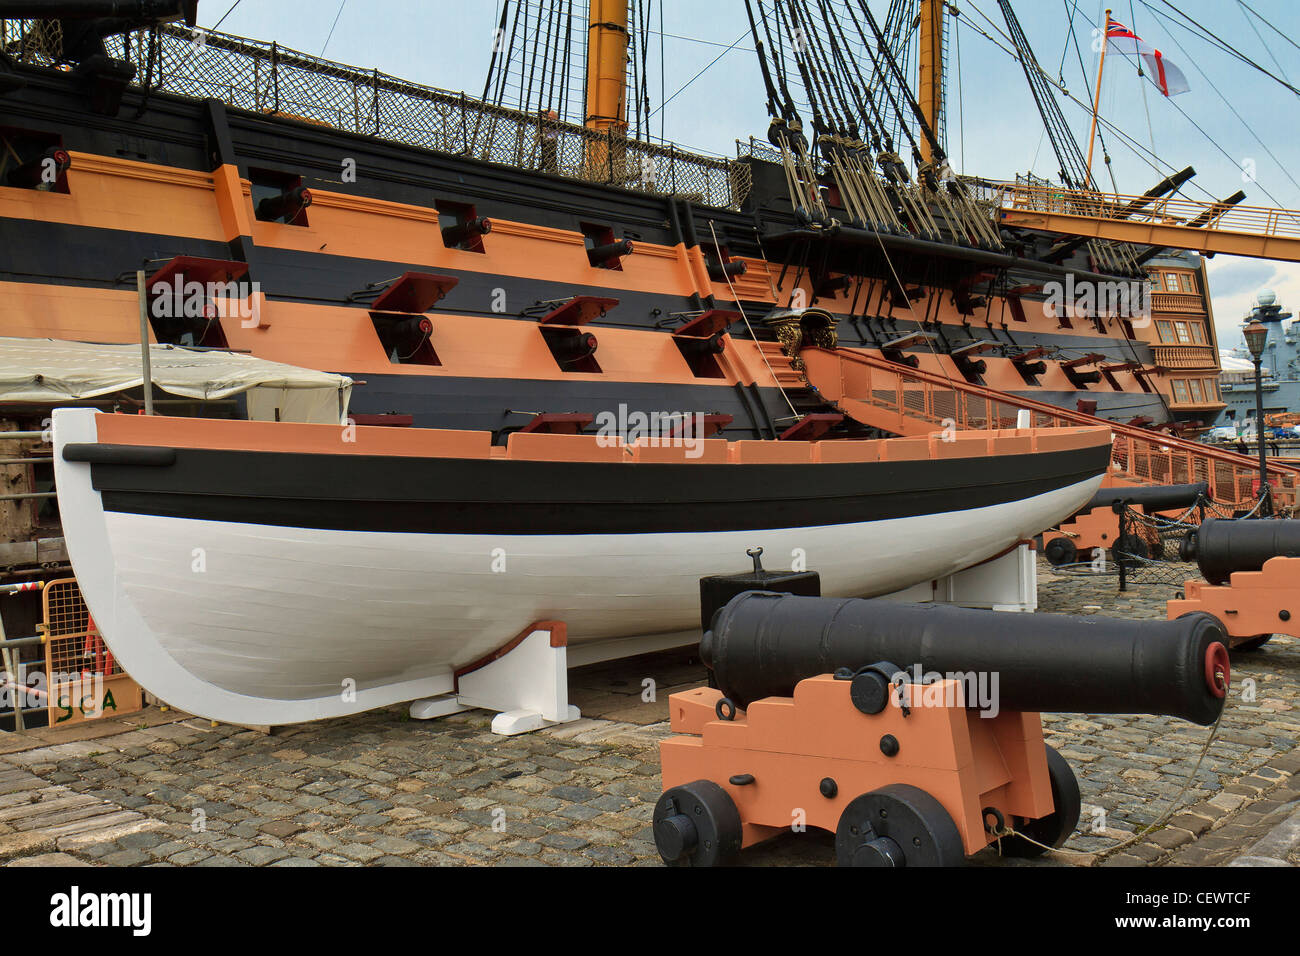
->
[654, 592, 1230, 866]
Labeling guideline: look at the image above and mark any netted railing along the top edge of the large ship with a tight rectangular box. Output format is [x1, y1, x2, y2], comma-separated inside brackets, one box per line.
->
[0, 20, 753, 208]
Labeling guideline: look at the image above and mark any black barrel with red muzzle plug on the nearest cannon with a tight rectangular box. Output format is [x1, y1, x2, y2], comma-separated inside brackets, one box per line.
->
[701, 592, 1229, 724]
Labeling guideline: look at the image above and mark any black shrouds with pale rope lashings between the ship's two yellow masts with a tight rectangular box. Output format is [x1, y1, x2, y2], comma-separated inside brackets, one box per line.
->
[745, 0, 1002, 248]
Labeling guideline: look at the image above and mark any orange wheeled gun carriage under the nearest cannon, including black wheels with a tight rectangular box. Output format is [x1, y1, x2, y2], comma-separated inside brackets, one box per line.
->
[655, 667, 1080, 866]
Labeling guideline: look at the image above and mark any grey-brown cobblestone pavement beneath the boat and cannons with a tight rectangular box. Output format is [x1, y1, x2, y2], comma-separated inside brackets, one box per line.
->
[0, 566, 1300, 866]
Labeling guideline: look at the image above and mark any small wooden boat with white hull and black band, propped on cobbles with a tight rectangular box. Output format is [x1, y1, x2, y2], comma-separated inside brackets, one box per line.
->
[55, 410, 1109, 723]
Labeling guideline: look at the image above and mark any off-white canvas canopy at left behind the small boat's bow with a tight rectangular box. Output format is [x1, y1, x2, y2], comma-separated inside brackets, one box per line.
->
[0, 337, 352, 424]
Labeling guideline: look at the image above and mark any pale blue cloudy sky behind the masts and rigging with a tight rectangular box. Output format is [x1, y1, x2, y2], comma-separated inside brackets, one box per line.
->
[199, 0, 1300, 347]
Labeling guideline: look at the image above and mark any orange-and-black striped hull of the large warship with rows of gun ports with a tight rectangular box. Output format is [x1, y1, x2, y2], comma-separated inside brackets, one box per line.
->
[0, 21, 1213, 438]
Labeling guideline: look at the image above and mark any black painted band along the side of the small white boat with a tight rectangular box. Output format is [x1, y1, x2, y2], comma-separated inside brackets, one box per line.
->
[78, 445, 1110, 535]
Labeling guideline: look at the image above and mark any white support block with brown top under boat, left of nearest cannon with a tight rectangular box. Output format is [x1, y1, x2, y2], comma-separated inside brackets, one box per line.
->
[411, 623, 582, 736]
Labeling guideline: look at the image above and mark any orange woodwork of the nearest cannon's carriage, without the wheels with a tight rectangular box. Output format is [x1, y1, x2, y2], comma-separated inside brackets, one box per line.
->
[659, 675, 1056, 855]
